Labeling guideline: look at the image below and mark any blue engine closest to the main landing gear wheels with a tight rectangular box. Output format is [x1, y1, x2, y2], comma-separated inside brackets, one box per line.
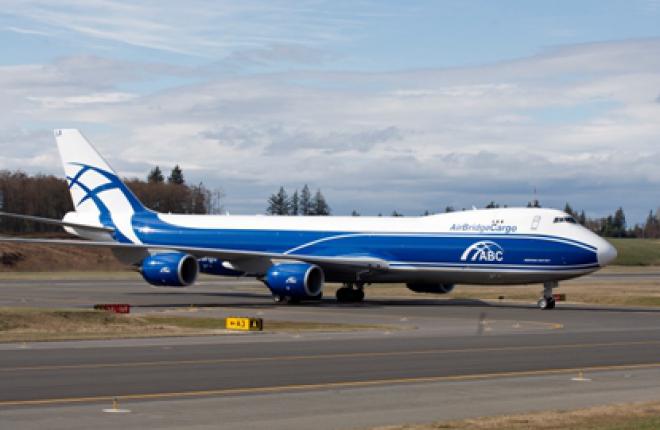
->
[264, 263, 325, 299]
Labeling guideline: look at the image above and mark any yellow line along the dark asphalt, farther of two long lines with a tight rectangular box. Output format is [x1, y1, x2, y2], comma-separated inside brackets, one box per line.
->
[0, 340, 660, 372]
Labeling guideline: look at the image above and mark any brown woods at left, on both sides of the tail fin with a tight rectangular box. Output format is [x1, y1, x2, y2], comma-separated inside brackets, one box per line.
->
[0, 165, 223, 233]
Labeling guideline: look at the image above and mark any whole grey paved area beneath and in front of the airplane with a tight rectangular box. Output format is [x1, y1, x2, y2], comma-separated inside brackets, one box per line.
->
[0, 274, 660, 429]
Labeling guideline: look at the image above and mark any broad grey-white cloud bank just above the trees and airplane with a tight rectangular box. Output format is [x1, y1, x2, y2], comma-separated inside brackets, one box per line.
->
[0, 38, 660, 220]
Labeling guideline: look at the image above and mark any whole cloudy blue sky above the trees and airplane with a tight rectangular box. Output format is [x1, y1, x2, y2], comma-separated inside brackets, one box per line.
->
[0, 0, 660, 224]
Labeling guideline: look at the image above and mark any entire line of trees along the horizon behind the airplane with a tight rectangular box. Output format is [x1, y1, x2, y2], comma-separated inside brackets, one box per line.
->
[0, 165, 660, 239]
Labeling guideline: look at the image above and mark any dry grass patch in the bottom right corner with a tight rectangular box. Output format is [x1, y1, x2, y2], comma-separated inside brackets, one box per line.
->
[377, 402, 660, 430]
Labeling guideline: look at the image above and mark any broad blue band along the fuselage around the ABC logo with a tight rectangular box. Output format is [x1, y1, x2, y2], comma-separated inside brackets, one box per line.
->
[125, 212, 598, 271]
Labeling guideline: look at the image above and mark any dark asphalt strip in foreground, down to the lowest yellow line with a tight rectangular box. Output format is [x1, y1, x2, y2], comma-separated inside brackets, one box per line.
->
[0, 332, 660, 406]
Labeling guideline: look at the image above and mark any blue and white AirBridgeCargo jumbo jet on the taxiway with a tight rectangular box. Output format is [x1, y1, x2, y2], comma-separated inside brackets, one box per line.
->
[0, 129, 617, 309]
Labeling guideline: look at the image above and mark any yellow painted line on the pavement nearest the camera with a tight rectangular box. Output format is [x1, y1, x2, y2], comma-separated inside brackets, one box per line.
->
[0, 363, 660, 407]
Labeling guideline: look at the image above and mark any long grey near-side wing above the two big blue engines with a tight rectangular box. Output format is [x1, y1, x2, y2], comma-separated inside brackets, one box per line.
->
[0, 237, 389, 270]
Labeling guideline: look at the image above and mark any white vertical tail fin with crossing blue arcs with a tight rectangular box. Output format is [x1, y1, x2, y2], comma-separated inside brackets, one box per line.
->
[55, 129, 148, 242]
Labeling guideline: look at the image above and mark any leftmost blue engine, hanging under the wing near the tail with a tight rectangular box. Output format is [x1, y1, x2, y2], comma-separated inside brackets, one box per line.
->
[140, 252, 199, 287]
